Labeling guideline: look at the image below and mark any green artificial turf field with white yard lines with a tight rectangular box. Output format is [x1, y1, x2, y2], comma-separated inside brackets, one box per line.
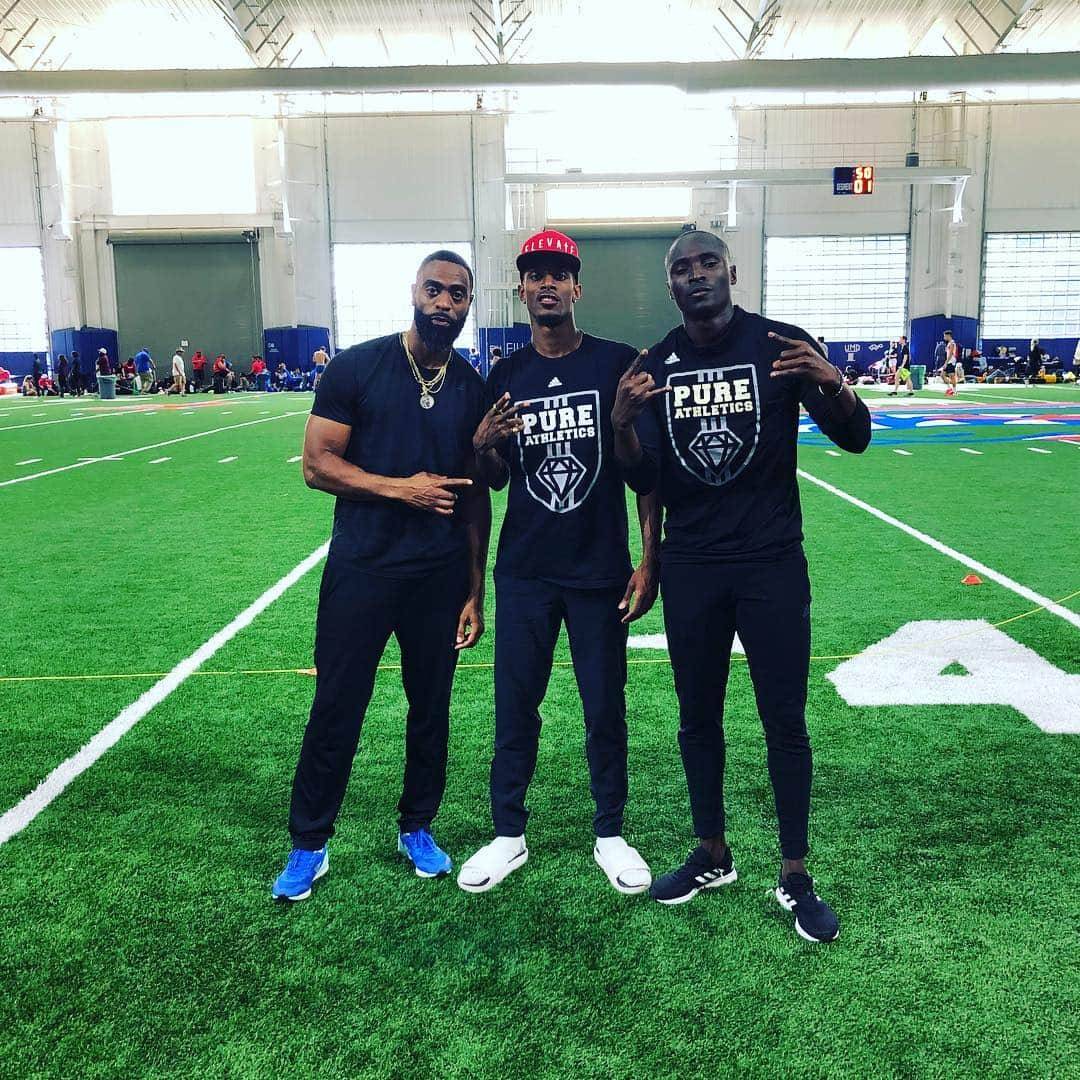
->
[0, 386, 1080, 1080]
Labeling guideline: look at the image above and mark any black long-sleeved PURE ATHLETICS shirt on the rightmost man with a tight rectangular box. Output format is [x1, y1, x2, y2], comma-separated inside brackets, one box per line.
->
[637, 308, 870, 563]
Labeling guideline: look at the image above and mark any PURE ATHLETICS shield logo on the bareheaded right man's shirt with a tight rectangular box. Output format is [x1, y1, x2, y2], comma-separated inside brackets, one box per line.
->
[664, 364, 761, 487]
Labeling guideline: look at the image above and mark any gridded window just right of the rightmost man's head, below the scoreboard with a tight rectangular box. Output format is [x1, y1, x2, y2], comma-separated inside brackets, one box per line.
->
[765, 234, 907, 341]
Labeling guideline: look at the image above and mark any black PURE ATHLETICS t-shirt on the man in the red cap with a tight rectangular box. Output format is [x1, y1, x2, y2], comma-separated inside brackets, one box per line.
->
[487, 334, 654, 589]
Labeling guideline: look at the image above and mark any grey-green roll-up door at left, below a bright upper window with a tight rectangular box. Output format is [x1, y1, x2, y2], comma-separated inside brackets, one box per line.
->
[112, 240, 262, 377]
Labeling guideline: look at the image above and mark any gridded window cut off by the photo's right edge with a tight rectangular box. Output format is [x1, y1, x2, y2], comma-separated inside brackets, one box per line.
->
[980, 232, 1080, 338]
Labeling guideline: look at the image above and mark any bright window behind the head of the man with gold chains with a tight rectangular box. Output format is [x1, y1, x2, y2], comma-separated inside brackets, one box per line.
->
[334, 241, 476, 349]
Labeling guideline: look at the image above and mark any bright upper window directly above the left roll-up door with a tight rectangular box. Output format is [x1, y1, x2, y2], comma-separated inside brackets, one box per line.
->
[108, 117, 255, 214]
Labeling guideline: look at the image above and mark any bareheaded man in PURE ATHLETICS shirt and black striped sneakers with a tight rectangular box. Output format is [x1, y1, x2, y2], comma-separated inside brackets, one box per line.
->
[639, 231, 870, 942]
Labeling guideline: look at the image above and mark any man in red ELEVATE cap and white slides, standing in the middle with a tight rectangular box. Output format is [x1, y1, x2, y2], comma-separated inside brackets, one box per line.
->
[458, 230, 658, 893]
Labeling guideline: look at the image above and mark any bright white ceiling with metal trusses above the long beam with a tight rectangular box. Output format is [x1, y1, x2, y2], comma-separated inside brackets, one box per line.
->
[0, 0, 1080, 70]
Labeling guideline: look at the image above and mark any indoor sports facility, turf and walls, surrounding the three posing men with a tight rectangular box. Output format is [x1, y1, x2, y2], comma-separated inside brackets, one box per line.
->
[0, 0, 1080, 1080]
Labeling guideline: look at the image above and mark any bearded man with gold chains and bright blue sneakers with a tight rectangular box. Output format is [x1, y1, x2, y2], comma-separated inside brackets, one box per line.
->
[272, 251, 491, 900]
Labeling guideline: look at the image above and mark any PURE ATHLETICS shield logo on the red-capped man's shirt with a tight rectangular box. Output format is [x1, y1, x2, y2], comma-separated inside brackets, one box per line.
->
[517, 390, 604, 514]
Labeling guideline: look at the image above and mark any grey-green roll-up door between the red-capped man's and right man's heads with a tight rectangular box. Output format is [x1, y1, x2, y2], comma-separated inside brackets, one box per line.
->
[575, 237, 680, 349]
